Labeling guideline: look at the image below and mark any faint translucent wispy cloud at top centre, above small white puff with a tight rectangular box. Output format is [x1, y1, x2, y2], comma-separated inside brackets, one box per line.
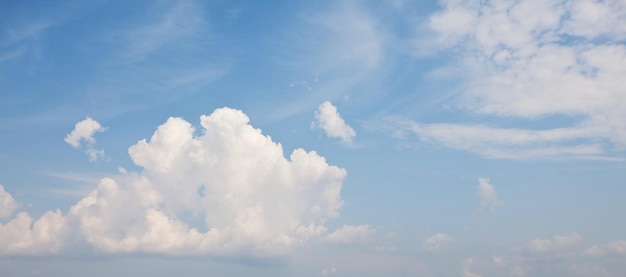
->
[260, 1, 392, 120]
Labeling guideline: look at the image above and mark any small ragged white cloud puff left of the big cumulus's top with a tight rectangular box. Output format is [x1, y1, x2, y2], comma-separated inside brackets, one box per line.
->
[65, 117, 106, 162]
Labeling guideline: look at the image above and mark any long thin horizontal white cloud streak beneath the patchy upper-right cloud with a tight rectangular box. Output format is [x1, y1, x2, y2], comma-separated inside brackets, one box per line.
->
[384, 117, 621, 160]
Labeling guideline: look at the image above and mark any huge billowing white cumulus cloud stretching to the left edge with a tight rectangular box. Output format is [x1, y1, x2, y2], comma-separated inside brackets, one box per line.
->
[0, 108, 346, 256]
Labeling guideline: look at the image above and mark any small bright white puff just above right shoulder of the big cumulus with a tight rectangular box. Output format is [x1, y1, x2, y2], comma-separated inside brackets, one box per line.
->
[311, 101, 356, 142]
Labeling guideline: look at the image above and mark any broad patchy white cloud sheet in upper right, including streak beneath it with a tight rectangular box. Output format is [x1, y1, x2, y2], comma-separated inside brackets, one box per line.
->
[400, 0, 626, 159]
